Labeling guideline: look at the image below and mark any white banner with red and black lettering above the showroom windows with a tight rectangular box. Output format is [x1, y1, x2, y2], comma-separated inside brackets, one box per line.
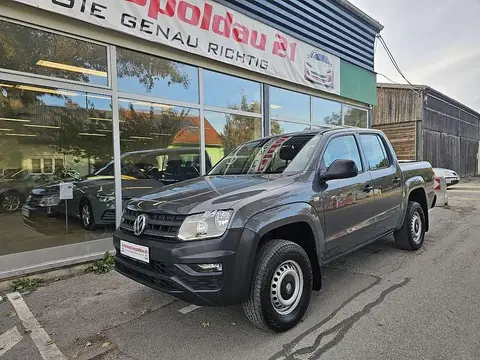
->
[30, 0, 340, 94]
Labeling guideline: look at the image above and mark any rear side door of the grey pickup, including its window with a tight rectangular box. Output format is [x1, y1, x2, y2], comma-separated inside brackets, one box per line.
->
[360, 133, 402, 236]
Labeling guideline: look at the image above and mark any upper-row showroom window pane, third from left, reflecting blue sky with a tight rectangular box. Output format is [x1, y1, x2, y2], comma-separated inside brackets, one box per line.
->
[203, 70, 261, 113]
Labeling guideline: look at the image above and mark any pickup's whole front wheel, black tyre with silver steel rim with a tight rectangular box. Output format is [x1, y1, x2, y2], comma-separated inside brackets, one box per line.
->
[243, 240, 313, 332]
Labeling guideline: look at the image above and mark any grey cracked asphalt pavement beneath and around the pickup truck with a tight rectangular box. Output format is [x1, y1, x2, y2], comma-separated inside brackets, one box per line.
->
[0, 179, 480, 360]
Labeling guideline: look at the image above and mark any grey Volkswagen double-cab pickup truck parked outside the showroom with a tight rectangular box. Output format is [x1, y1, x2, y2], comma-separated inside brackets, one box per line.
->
[113, 128, 436, 332]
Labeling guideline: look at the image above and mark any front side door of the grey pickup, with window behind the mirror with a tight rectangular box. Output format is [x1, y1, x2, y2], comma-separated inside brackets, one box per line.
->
[318, 134, 375, 259]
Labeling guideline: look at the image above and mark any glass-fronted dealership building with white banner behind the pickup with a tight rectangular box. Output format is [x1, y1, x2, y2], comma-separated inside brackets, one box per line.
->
[0, 0, 382, 279]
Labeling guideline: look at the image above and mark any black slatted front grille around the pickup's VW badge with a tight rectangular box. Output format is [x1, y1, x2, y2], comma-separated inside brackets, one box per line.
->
[120, 209, 186, 241]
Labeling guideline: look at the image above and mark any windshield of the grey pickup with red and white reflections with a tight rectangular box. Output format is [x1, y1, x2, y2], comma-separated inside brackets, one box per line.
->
[208, 134, 320, 175]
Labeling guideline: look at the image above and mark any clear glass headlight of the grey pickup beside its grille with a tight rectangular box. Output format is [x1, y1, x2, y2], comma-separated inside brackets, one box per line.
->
[178, 210, 233, 241]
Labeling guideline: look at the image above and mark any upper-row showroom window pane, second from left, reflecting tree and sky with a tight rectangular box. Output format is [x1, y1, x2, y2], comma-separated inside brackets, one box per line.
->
[117, 48, 198, 103]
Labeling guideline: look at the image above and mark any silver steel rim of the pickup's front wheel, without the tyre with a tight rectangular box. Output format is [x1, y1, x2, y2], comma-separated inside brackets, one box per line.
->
[270, 260, 303, 315]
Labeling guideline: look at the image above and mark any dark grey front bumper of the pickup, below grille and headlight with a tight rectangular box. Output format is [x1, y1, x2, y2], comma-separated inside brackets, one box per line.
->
[113, 229, 256, 306]
